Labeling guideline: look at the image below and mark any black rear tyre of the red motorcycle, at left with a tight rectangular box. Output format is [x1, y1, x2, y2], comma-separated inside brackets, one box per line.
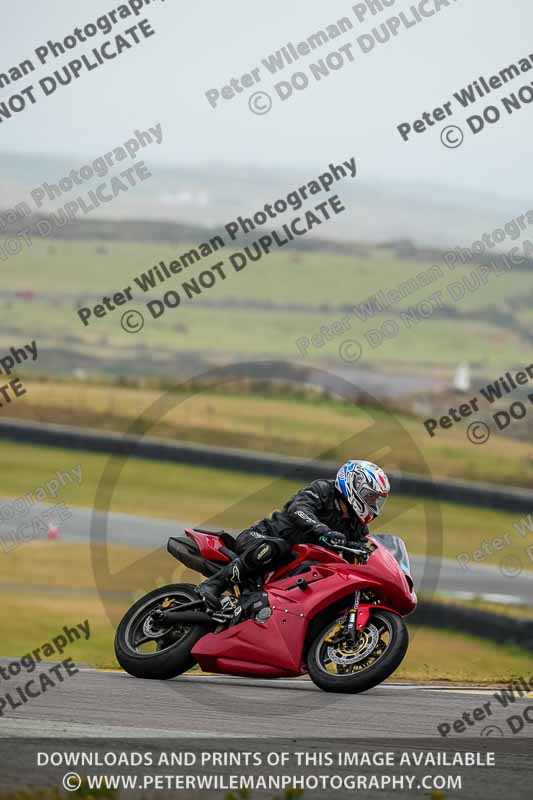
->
[115, 583, 208, 680]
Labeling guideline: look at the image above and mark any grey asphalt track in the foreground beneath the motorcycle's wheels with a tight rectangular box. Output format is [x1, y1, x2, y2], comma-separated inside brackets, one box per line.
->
[0, 660, 533, 742]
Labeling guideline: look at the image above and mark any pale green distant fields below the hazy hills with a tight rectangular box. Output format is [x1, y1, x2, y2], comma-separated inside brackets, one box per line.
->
[0, 240, 533, 371]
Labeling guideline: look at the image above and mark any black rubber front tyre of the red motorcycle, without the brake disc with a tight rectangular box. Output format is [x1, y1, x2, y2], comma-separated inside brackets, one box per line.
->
[307, 609, 409, 694]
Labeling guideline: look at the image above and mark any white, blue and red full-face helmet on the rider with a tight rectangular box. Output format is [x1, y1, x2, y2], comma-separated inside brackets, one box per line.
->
[335, 461, 390, 525]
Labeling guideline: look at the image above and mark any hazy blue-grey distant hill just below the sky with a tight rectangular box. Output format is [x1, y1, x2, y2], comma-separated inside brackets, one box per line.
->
[0, 148, 528, 246]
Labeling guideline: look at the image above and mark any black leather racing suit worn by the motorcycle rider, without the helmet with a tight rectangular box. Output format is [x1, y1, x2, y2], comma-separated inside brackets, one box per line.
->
[198, 480, 368, 602]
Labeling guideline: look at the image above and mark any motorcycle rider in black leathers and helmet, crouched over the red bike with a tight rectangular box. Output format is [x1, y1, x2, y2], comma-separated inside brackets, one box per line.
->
[197, 461, 390, 609]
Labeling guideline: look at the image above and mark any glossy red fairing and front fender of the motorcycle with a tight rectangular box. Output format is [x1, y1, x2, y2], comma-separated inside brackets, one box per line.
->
[192, 534, 416, 678]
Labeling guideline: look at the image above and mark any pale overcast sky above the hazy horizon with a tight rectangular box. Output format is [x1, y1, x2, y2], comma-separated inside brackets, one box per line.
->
[0, 0, 533, 196]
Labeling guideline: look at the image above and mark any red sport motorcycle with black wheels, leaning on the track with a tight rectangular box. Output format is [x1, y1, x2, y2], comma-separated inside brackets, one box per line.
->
[115, 529, 417, 692]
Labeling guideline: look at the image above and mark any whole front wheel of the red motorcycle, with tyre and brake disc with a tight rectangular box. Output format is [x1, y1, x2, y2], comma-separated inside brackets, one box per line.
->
[307, 609, 409, 694]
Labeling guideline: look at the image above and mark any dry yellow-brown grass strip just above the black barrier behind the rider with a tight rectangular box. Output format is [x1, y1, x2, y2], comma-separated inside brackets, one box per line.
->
[9, 381, 533, 488]
